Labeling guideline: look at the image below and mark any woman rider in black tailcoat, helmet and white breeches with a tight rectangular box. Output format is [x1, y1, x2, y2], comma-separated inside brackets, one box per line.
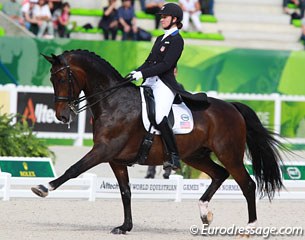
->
[130, 3, 208, 170]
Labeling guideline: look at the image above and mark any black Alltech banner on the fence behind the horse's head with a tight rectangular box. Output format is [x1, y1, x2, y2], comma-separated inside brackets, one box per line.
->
[17, 92, 77, 132]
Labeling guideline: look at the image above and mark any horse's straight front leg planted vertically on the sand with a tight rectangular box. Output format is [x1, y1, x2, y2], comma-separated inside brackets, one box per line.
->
[110, 163, 133, 234]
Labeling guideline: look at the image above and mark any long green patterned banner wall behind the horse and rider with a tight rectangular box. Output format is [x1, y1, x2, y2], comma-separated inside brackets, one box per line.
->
[0, 36, 305, 95]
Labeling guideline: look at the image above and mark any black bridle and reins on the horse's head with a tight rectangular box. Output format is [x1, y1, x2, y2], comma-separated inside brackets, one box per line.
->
[51, 56, 133, 114]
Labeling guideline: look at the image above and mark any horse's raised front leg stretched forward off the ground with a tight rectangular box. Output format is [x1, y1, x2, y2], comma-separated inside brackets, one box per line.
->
[31, 146, 107, 197]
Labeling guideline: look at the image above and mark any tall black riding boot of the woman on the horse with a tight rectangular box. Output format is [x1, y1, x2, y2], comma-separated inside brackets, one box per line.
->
[158, 117, 181, 170]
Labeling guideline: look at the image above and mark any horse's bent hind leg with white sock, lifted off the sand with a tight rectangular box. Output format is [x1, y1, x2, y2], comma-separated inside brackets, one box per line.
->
[185, 152, 229, 224]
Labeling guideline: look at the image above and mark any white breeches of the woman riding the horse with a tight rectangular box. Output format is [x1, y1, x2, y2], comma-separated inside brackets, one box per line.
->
[143, 76, 175, 124]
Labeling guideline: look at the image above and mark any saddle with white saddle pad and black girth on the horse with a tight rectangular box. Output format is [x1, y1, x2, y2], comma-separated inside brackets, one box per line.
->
[136, 86, 194, 164]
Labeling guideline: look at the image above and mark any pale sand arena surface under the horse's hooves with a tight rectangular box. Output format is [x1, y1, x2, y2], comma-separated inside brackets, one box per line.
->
[0, 198, 305, 240]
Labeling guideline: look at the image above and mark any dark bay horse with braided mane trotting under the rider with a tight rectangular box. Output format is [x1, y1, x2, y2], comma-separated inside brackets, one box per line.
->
[32, 50, 283, 234]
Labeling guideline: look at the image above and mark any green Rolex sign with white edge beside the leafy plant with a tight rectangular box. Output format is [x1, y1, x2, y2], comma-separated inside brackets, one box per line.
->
[0, 157, 56, 177]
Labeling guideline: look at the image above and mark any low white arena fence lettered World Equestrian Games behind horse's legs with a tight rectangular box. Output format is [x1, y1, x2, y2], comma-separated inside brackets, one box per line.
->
[0, 172, 305, 202]
